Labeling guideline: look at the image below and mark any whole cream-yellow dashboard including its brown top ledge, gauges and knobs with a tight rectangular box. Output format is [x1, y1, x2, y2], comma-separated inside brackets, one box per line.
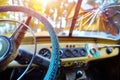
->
[13, 37, 119, 67]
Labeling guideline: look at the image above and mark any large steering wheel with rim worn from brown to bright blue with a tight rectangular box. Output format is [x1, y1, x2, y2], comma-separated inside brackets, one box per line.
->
[0, 6, 59, 80]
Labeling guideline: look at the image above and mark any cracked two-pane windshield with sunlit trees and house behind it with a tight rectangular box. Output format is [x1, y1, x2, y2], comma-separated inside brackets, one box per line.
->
[0, 0, 120, 39]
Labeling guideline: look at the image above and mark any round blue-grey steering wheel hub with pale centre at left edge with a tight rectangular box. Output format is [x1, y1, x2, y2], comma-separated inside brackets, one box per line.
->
[0, 36, 10, 60]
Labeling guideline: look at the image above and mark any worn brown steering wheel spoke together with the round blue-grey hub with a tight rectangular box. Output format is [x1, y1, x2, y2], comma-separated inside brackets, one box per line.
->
[0, 17, 31, 71]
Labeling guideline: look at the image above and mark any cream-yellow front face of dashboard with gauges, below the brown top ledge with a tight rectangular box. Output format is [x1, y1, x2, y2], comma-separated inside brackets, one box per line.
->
[19, 40, 119, 67]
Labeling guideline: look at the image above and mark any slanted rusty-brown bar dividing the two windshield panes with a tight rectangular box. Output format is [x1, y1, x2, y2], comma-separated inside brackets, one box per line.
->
[69, 0, 82, 37]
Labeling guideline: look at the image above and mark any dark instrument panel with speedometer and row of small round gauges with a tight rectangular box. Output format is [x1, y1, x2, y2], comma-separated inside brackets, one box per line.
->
[38, 48, 87, 59]
